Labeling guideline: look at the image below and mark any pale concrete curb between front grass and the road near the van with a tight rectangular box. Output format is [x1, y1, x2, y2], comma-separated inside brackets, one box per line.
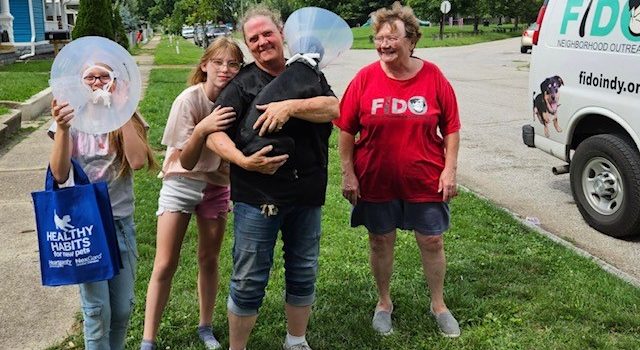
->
[458, 184, 640, 288]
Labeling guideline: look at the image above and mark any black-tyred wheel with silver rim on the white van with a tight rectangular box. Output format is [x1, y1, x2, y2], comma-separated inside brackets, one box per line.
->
[570, 134, 640, 237]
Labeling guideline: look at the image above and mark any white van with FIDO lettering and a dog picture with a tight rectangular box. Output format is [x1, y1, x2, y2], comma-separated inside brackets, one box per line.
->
[522, 0, 640, 237]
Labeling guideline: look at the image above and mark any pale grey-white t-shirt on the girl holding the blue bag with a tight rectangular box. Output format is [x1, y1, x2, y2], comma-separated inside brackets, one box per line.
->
[49, 122, 134, 219]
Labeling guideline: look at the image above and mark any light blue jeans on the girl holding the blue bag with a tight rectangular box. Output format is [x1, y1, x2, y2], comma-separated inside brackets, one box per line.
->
[80, 216, 138, 350]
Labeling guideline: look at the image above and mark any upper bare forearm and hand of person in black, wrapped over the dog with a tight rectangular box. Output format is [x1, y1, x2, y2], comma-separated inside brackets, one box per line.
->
[253, 96, 340, 136]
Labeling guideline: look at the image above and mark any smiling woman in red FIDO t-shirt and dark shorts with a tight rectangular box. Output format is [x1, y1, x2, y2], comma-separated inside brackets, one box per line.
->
[334, 2, 460, 337]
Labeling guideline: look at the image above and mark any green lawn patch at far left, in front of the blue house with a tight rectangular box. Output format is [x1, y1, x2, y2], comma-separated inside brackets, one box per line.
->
[0, 59, 53, 102]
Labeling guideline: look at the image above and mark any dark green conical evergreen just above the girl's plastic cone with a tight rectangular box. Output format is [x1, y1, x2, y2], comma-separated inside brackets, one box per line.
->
[71, 0, 114, 40]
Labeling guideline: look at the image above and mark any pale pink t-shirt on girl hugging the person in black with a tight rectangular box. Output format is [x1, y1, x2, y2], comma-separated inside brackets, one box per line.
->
[161, 83, 229, 186]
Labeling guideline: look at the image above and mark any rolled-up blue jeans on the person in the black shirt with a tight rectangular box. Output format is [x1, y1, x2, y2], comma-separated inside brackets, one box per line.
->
[227, 203, 321, 316]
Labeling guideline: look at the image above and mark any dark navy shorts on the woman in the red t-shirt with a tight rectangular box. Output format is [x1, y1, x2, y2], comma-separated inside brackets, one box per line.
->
[351, 199, 451, 235]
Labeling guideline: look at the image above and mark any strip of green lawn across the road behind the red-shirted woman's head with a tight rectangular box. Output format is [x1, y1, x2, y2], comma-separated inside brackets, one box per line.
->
[351, 25, 523, 49]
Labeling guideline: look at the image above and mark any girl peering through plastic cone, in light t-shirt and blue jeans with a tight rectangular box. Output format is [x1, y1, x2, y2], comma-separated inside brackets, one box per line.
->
[49, 63, 155, 350]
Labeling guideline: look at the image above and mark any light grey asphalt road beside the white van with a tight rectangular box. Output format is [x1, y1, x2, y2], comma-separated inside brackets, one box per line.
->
[325, 38, 640, 279]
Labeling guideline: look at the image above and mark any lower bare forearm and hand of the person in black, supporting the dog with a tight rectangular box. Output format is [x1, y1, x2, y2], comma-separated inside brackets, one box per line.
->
[207, 131, 289, 175]
